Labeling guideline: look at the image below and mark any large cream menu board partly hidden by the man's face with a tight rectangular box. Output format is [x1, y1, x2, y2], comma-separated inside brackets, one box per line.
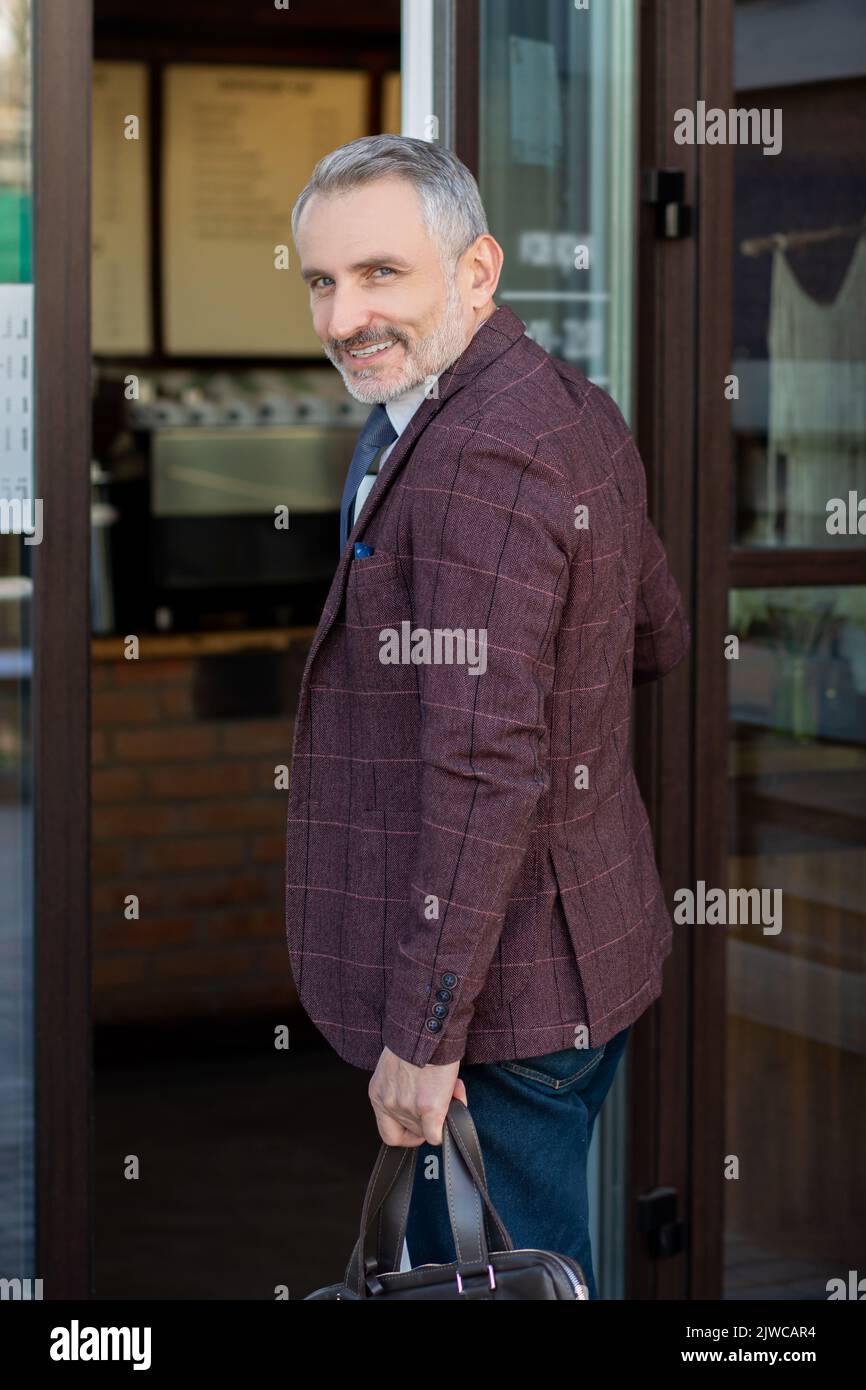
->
[163, 64, 368, 357]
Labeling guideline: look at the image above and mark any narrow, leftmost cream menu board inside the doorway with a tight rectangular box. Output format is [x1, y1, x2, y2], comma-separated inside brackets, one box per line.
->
[90, 63, 153, 353]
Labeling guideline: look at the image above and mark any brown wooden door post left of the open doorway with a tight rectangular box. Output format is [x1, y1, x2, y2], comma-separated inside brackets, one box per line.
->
[32, 0, 93, 1300]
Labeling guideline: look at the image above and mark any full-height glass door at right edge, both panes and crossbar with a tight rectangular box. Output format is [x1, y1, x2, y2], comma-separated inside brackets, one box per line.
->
[724, 0, 866, 1300]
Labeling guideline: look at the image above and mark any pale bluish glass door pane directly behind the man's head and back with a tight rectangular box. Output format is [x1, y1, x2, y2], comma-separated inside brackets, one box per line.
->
[475, 0, 637, 1298]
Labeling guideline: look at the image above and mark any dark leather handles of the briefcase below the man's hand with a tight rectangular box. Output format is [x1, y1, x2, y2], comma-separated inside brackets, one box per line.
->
[345, 1098, 514, 1298]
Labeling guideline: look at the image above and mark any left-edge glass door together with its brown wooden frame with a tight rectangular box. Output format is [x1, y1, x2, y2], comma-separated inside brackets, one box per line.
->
[0, 0, 92, 1298]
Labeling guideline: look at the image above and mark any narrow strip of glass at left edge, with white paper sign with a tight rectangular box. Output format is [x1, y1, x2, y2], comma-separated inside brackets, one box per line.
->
[0, 0, 40, 1298]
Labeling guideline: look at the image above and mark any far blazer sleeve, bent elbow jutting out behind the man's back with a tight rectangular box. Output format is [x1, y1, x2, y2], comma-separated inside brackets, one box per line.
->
[632, 514, 691, 685]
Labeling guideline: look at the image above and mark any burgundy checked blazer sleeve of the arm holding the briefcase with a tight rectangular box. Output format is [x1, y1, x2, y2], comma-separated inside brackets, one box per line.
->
[382, 432, 575, 1066]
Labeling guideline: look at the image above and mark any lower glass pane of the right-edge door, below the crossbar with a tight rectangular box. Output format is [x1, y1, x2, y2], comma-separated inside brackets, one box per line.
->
[726, 588, 866, 1298]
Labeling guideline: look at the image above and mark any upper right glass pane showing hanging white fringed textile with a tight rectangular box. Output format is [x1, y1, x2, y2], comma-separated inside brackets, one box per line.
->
[731, 0, 866, 549]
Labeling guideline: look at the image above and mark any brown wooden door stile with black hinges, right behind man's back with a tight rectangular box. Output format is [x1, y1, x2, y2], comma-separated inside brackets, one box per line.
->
[628, 0, 698, 1298]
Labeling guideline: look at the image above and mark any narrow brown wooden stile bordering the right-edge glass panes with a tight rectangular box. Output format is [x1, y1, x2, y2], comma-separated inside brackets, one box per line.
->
[687, 0, 734, 1298]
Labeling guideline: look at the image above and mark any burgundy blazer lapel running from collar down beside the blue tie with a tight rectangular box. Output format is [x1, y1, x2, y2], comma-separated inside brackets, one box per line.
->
[297, 304, 525, 673]
